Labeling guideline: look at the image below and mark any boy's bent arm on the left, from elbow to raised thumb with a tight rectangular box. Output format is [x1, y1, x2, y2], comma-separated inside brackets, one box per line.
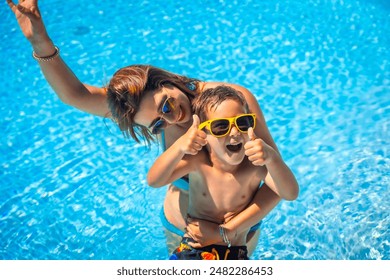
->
[147, 115, 207, 188]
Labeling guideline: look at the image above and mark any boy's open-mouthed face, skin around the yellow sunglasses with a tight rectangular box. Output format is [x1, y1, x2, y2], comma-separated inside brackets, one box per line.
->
[201, 100, 248, 165]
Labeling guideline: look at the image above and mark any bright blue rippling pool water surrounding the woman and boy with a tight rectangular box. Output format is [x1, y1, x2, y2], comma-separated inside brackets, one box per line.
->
[0, 0, 390, 260]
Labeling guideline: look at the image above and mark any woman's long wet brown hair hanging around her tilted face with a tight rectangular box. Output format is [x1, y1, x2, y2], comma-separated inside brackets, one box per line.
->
[106, 65, 199, 144]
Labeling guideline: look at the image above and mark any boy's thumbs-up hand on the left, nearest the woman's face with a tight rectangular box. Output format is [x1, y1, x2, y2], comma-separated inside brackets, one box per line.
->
[180, 115, 207, 155]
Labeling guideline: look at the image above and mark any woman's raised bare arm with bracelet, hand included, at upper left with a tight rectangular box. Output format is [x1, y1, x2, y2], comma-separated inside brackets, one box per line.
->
[7, 0, 109, 117]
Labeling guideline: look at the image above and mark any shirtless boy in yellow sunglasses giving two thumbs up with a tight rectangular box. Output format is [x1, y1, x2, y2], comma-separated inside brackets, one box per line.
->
[148, 86, 298, 260]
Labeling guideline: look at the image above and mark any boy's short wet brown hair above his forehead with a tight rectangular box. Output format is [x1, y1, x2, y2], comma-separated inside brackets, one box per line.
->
[192, 85, 249, 122]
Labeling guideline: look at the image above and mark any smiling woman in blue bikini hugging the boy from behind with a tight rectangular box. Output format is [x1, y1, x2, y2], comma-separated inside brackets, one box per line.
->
[7, 0, 280, 254]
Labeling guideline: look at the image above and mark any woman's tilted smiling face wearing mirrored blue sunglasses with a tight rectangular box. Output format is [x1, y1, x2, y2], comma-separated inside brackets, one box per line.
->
[134, 86, 192, 133]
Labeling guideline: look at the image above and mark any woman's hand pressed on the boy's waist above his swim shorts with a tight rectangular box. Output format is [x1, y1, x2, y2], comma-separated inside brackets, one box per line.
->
[186, 217, 222, 248]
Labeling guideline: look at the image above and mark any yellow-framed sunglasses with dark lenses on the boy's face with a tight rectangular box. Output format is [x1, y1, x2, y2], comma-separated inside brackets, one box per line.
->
[199, 114, 256, 138]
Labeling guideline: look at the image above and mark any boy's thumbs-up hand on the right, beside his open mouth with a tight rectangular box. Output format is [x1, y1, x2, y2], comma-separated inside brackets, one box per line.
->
[244, 127, 277, 166]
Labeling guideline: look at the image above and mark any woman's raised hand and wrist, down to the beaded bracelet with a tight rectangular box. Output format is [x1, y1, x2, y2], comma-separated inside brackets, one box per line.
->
[7, 0, 53, 50]
